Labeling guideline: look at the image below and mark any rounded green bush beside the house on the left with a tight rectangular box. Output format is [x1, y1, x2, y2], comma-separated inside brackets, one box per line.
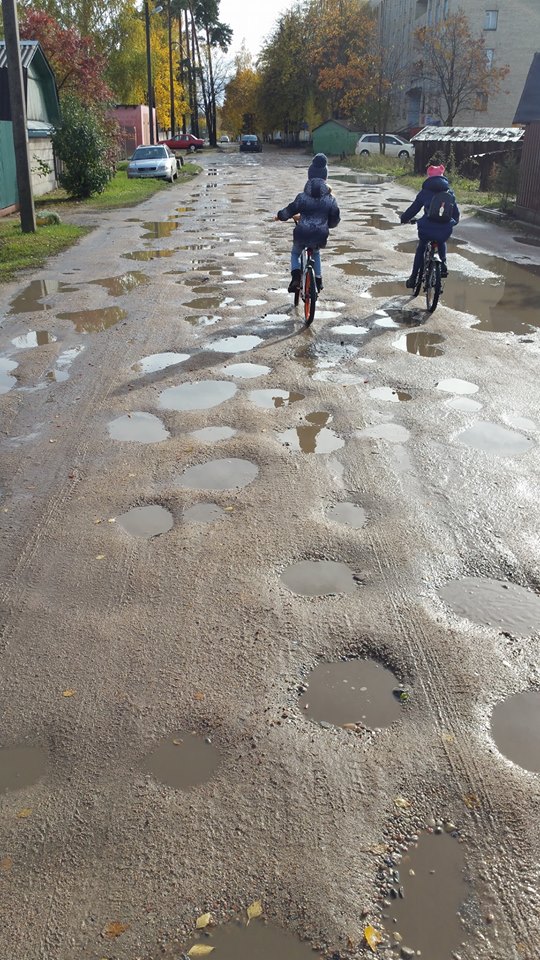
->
[52, 96, 116, 199]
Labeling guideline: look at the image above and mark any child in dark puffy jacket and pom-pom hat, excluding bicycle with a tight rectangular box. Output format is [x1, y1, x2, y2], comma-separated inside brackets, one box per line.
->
[274, 153, 341, 293]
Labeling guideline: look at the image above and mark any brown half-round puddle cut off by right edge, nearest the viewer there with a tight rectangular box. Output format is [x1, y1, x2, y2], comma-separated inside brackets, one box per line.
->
[491, 690, 540, 773]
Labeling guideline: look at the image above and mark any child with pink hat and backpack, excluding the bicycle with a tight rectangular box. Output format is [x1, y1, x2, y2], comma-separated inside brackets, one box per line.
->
[400, 163, 459, 289]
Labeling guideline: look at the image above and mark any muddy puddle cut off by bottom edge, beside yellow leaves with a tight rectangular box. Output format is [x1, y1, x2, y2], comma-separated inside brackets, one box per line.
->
[181, 918, 321, 960]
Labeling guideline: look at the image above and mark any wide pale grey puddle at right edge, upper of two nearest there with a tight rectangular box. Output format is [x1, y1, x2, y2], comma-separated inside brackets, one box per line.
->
[438, 577, 540, 637]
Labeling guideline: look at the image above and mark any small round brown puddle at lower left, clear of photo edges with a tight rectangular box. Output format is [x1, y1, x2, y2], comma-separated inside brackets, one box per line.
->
[143, 732, 219, 790]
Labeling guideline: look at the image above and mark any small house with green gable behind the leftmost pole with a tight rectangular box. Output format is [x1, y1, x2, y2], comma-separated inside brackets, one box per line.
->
[0, 40, 60, 216]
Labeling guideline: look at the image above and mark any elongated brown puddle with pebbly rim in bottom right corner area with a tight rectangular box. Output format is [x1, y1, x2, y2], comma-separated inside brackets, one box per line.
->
[387, 833, 468, 960]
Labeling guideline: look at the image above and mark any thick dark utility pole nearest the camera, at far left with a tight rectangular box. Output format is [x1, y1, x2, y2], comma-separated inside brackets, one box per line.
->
[2, 0, 36, 233]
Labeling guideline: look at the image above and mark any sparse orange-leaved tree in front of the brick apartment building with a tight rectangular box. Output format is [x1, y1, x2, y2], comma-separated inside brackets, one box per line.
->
[415, 11, 509, 126]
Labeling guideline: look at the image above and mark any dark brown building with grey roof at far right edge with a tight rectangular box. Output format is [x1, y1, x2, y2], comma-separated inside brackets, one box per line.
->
[514, 53, 540, 225]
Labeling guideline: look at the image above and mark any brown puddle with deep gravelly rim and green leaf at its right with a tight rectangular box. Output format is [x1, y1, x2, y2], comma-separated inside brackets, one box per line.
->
[298, 660, 403, 728]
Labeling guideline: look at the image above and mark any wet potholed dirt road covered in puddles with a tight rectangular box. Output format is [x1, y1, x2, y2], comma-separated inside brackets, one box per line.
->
[0, 151, 540, 960]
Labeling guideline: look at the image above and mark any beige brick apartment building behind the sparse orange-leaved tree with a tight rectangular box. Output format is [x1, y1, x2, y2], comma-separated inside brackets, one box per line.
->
[371, 0, 540, 131]
